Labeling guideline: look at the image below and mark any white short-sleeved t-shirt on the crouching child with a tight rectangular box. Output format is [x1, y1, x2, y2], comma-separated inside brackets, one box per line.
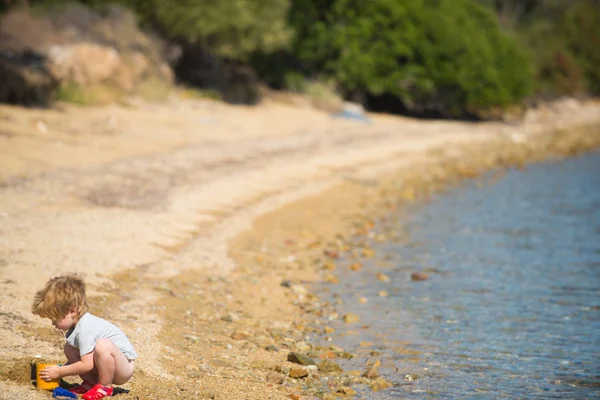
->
[65, 312, 137, 360]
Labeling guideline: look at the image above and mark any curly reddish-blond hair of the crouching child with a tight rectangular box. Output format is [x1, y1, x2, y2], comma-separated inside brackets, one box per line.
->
[31, 275, 88, 320]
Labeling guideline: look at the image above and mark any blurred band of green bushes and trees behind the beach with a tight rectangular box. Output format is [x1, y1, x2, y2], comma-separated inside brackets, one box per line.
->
[0, 0, 600, 117]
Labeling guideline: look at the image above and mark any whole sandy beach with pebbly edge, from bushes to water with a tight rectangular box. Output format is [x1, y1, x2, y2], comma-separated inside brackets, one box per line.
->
[0, 99, 600, 400]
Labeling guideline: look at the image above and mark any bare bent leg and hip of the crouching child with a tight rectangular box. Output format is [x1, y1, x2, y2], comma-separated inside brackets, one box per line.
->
[94, 339, 134, 386]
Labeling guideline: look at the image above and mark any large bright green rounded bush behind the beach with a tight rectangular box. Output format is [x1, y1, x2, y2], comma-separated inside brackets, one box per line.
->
[292, 0, 531, 115]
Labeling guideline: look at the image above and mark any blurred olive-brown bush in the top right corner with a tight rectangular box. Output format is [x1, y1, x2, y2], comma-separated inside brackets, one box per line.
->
[480, 0, 600, 98]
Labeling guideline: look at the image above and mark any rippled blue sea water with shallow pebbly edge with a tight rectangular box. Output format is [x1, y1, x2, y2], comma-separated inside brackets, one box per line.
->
[321, 153, 600, 399]
